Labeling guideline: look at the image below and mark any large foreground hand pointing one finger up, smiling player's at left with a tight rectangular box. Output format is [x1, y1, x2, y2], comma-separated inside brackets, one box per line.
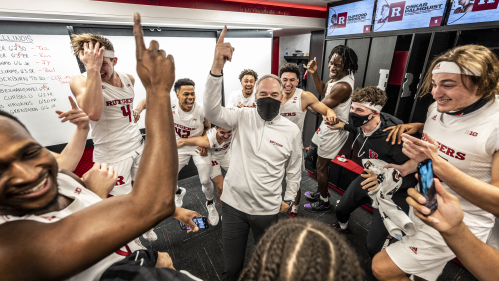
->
[133, 13, 175, 95]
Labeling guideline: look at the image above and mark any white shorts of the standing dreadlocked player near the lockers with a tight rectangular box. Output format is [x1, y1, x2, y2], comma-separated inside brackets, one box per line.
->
[312, 122, 349, 159]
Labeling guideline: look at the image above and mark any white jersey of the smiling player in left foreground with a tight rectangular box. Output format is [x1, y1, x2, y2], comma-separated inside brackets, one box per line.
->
[0, 173, 142, 281]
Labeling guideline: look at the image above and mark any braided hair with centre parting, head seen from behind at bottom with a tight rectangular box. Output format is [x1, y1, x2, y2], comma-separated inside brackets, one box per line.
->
[239, 218, 363, 281]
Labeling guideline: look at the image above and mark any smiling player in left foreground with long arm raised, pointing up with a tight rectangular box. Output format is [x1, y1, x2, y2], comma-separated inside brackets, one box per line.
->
[0, 14, 200, 281]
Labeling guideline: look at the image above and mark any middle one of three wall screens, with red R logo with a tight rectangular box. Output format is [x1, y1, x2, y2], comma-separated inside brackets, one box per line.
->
[373, 0, 447, 32]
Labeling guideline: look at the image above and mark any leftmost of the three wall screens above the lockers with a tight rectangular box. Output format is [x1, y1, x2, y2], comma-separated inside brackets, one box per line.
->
[327, 0, 374, 36]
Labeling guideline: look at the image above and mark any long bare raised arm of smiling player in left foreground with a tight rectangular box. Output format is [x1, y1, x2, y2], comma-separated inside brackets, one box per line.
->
[0, 14, 178, 280]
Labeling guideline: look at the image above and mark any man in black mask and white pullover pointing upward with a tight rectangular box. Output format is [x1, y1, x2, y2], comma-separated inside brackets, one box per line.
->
[203, 29, 302, 280]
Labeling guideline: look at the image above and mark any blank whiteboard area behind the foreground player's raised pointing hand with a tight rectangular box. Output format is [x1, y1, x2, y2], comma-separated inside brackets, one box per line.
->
[106, 36, 216, 128]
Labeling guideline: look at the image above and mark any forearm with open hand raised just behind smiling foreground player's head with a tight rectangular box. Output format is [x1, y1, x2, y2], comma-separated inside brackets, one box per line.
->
[52, 97, 90, 171]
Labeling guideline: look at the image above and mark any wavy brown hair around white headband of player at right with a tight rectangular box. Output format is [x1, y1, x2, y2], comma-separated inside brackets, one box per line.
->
[418, 45, 499, 100]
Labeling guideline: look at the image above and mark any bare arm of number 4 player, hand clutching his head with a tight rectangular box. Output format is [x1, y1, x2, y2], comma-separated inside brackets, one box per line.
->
[69, 42, 105, 121]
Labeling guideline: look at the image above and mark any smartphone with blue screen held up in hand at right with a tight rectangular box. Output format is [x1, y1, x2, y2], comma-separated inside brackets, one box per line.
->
[418, 159, 438, 214]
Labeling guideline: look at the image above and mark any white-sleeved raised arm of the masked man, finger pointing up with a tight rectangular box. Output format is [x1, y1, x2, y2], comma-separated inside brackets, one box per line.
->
[203, 26, 240, 130]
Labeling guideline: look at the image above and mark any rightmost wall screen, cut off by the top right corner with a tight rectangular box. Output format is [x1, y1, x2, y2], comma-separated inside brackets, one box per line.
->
[447, 0, 499, 25]
